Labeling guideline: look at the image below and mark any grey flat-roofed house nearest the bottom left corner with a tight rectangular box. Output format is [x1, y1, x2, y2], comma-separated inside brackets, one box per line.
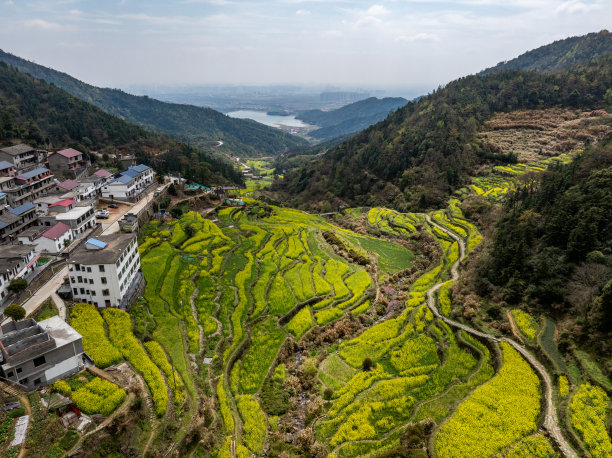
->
[0, 316, 93, 390]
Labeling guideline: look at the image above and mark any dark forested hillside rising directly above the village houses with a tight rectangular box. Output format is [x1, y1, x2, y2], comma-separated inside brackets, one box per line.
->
[0, 62, 242, 183]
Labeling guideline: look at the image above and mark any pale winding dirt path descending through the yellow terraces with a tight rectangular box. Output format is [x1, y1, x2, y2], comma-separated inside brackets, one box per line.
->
[425, 215, 578, 458]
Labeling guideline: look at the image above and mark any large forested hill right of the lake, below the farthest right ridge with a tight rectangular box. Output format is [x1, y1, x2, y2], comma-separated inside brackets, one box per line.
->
[272, 56, 612, 211]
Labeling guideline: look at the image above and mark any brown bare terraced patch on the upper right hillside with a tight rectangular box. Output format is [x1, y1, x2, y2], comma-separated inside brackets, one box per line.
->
[479, 109, 612, 162]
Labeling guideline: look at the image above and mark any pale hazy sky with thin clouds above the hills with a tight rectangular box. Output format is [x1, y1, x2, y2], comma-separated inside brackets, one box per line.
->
[0, 0, 612, 88]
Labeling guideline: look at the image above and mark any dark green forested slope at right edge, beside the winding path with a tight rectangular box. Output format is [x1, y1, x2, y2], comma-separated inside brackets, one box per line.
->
[473, 135, 612, 354]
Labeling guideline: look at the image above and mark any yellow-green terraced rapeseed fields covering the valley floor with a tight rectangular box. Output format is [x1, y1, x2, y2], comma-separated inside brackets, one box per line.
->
[67, 150, 608, 457]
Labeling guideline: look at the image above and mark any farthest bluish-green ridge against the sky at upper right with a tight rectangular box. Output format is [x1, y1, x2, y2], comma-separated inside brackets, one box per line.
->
[480, 30, 612, 75]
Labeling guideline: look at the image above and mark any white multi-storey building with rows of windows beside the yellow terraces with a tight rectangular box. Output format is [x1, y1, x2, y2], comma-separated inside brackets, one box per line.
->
[68, 233, 144, 308]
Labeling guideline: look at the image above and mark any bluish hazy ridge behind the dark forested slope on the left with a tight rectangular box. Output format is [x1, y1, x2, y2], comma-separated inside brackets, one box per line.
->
[0, 50, 306, 156]
